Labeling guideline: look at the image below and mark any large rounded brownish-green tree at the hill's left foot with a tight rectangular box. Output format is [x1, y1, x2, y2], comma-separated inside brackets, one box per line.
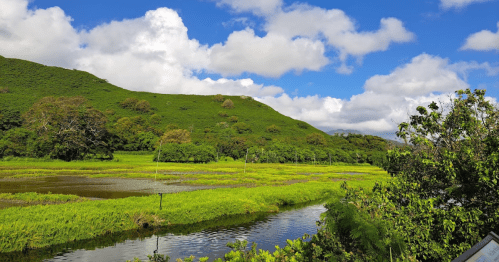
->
[23, 96, 112, 161]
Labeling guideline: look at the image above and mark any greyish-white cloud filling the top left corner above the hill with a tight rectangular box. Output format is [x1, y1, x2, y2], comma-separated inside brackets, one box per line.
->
[0, 0, 80, 67]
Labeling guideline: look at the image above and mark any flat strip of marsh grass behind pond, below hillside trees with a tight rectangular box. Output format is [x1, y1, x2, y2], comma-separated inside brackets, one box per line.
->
[0, 152, 387, 186]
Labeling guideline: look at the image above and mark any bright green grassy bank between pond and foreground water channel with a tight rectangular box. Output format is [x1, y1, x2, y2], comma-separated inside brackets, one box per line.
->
[0, 180, 372, 252]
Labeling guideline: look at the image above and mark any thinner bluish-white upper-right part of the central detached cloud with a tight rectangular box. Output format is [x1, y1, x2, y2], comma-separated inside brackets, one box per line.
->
[265, 4, 415, 74]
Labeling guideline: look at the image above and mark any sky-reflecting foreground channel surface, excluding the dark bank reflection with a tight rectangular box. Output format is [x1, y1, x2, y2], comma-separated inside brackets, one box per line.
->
[43, 204, 326, 262]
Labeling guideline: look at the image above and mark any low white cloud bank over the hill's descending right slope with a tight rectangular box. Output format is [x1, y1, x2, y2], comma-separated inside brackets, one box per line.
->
[257, 53, 499, 139]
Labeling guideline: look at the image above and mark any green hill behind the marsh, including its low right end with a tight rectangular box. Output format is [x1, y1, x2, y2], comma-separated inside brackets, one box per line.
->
[0, 56, 400, 164]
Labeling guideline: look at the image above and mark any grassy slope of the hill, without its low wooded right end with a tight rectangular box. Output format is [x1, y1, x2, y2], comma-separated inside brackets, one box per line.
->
[0, 56, 322, 142]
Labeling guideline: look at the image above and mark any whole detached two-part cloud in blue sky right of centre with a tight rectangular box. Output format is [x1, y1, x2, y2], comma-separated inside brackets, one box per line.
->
[210, 3, 415, 77]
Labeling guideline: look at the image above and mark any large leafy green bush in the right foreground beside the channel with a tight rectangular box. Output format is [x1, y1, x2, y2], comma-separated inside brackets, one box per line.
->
[318, 89, 499, 262]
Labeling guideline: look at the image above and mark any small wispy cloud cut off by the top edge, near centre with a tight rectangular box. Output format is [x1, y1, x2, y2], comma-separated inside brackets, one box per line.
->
[213, 0, 283, 15]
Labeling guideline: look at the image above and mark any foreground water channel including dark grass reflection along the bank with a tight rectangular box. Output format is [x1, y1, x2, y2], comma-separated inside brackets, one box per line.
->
[0, 202, 325, 262]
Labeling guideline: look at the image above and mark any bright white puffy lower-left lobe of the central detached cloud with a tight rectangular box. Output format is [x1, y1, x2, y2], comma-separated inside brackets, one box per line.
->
[210, 28, 329, 77]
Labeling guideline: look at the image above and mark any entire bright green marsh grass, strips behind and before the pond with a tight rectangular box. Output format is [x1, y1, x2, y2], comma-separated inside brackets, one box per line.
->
[0, 154, 389, 252]
